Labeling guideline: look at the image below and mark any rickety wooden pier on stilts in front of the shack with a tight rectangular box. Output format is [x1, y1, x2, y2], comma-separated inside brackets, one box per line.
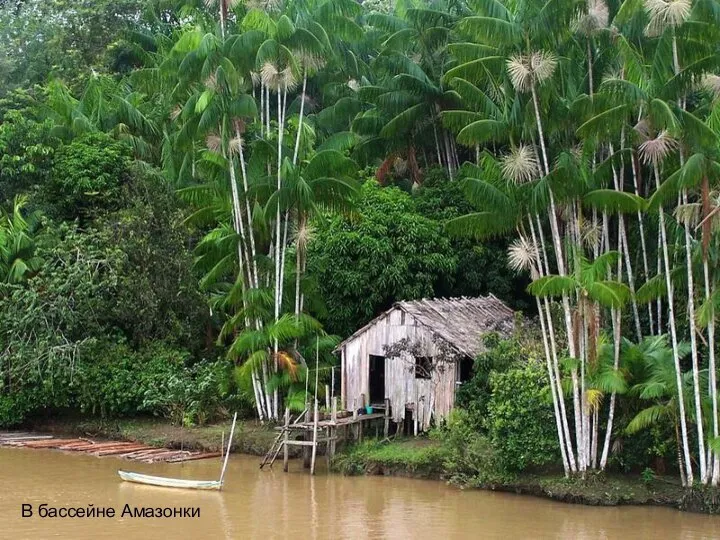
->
[260, 396, 390, 474]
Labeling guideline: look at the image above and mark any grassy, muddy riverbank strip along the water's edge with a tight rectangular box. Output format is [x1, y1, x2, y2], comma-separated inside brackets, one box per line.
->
[15, 418, 720, 514]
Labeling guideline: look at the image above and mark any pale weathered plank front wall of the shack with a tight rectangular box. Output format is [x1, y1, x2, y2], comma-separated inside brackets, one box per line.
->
[341, 308, 456, 431]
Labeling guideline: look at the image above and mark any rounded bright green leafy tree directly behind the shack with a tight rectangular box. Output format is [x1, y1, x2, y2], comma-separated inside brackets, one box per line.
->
[308, 181, 457, 335]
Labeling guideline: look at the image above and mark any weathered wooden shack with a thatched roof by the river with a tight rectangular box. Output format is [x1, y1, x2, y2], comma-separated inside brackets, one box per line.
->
[336, 295, 515, 431]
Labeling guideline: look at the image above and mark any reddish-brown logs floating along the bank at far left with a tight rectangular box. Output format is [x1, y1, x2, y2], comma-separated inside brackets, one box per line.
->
[0, 432, 220, 463]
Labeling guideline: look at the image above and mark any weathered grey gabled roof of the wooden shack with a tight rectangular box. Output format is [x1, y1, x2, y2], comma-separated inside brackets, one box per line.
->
[336, 294, 514, 358]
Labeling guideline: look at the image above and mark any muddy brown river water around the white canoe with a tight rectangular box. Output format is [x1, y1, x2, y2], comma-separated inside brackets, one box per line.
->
[0, 448, 720, 540]
